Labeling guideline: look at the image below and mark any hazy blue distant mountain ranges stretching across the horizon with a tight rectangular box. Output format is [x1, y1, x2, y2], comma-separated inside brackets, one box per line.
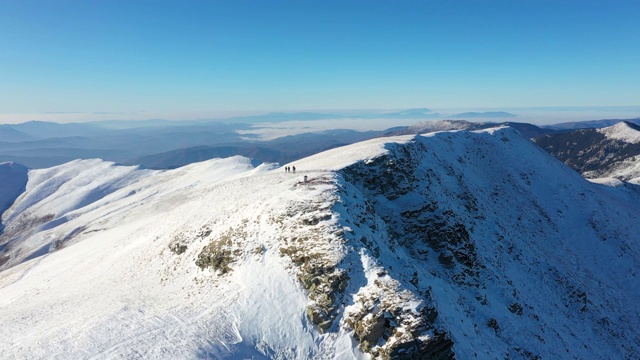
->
[0, 108, 640, 173]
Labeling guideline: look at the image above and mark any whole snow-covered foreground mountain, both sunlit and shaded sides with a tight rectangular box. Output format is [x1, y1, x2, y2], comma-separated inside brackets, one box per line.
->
[0, 128, 640, 359]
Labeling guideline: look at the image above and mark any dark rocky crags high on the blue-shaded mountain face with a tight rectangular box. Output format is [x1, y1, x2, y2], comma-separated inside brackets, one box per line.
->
[344, 142, 482, 285]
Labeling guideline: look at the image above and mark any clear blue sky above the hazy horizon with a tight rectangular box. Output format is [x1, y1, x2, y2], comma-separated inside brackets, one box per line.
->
[0, 0, 640, 118]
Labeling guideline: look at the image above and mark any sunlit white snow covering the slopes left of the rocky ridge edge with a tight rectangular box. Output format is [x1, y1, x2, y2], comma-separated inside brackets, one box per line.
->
[0, 157, 357, 359]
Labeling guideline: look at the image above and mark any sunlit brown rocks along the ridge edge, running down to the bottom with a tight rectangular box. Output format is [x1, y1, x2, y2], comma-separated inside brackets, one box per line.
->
[272, 172, 454, 359]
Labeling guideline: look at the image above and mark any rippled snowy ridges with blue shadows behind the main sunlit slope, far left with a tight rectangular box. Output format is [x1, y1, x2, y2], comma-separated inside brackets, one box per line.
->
[0, 157, 268, 269]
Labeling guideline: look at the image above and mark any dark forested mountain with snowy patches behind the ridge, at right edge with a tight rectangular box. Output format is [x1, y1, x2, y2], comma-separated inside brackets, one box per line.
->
[534, 121, 640, 183]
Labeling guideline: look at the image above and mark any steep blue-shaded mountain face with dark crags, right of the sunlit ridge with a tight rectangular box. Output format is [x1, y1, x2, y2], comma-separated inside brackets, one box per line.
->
[330, 129, 640, 359]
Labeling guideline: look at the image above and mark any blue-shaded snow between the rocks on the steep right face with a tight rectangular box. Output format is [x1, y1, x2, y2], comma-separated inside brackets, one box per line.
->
[328, 128, 640, 358]
